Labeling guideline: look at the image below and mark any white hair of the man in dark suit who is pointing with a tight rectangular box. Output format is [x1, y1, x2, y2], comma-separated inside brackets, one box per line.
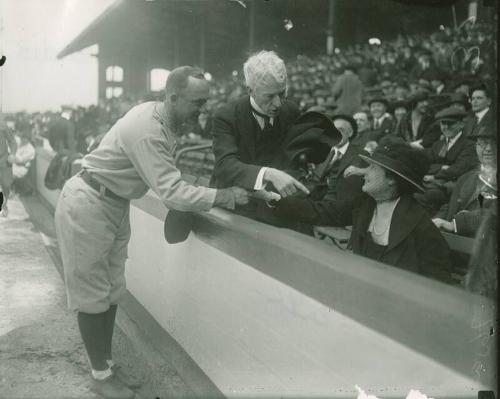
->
[243, 50, 287, 89]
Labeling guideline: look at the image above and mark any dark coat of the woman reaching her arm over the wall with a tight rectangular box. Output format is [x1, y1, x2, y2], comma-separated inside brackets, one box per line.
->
[275, 195, 451, 282]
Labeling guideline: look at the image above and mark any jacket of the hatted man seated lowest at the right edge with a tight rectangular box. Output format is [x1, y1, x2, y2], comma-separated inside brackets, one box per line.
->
[435, 169, 491, 237]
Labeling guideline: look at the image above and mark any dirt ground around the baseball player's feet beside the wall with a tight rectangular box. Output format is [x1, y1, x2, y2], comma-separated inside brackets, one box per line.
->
[0, 198, 205, 399]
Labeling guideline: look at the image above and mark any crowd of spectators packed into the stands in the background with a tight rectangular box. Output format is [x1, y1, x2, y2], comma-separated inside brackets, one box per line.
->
[2, 19, 497, 253]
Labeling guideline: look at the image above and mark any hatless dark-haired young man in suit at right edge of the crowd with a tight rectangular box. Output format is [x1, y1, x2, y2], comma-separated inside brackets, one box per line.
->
[464, 85, 495, 136]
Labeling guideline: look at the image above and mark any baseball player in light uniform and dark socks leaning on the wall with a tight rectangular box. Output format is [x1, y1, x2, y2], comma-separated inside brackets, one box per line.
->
[55, 66, 248, 399]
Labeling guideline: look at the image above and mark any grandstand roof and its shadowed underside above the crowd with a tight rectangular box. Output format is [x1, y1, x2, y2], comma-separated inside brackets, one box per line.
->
[58, 0, 460, 70]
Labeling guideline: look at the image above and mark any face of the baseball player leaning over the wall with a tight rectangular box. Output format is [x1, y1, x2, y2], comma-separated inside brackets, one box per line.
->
[172, 77, 210, 122]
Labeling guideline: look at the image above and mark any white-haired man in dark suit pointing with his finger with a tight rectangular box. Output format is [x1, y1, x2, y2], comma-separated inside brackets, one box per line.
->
[212, 51, 308, 225]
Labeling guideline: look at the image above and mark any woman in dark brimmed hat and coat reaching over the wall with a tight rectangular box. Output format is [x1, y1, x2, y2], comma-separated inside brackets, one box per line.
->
[275, 136, 451, 282]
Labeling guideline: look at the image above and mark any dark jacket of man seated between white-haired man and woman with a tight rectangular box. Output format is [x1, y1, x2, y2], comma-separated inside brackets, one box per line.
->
[324, 142, 370, 200]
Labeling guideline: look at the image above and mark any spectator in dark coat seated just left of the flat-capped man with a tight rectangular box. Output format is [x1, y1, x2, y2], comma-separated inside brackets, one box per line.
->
[395, 91, 440, 148]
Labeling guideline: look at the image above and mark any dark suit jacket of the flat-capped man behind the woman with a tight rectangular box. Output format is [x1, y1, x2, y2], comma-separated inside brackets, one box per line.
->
[425, 133, 478, 181]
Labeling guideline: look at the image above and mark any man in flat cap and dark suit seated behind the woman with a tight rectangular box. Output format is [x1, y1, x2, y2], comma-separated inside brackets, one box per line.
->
[415, 107, 477, 215]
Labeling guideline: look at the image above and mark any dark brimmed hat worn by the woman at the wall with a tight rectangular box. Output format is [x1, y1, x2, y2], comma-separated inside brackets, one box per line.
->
[359, 136, 429, 192]
